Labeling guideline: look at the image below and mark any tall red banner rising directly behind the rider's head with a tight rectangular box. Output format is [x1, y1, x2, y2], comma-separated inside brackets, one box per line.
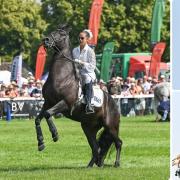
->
[88, 0, 104, 45]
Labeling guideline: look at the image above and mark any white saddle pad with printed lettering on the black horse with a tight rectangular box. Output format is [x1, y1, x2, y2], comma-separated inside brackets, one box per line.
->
[79, 86, 104, 107]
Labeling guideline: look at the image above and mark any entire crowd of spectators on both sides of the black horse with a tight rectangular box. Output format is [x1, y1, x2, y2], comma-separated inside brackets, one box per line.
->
[0, 71, 169, 116]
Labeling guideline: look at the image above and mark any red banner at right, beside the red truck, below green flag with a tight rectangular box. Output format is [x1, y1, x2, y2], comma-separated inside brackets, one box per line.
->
[149, 42, 166, 78]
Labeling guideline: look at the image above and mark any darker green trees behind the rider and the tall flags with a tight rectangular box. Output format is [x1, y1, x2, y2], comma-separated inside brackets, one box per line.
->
[42, 0, 170, 61]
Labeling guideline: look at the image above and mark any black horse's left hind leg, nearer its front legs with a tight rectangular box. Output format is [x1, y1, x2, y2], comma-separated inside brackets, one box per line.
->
[81, 123, 99, 167]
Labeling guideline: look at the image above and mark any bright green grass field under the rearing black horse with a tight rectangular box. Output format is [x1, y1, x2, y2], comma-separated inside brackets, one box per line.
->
[0, 116, 169, 180]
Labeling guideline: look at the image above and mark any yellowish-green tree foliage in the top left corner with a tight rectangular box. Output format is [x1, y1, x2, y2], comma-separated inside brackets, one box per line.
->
[0, 0, 46, 66]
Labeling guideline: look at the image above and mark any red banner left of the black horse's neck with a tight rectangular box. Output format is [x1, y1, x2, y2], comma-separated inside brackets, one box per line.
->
[35, 45, 46, 80]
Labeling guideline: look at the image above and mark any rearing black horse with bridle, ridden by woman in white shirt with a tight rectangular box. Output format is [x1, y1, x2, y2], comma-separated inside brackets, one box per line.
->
[35, 25, 122, 167]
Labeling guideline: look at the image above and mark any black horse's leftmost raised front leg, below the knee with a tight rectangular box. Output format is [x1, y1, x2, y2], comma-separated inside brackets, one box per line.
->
[35, 109, 45, 151]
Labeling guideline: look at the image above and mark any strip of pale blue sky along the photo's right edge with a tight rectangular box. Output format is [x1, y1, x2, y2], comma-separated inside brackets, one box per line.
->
[170, 0, 180, 180]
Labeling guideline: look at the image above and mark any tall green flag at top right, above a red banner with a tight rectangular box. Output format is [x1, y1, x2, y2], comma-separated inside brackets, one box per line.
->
[151, 0, 165, 44]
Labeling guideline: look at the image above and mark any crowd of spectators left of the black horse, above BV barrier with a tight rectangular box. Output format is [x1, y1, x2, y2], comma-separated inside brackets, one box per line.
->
[0, 74, 44, 98]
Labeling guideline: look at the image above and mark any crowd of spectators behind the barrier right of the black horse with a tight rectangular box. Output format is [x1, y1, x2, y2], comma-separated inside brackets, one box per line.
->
[99, 75, 169, 116]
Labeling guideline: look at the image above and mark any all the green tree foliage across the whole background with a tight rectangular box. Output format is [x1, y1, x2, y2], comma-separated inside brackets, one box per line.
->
[0, 0, 170, 69]
